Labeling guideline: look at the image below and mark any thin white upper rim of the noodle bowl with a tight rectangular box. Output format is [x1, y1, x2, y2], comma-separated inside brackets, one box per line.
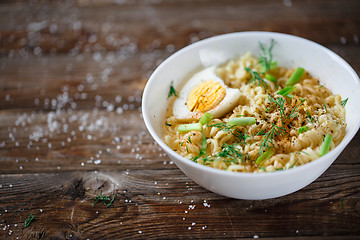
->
[142, 31, 360, 178]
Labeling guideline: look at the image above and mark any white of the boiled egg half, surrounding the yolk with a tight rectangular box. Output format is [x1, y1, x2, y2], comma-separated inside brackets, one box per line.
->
[173, 66, 241, 119]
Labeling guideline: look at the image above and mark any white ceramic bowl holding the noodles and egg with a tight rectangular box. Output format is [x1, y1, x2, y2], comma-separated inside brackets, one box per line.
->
[142, 32, 360, 200]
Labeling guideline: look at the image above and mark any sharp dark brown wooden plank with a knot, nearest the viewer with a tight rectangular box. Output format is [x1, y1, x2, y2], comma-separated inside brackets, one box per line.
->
[0, 166, 360, 239]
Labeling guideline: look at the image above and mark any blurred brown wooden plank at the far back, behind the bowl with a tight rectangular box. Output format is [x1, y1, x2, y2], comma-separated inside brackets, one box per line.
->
[0, 0, 360, 54]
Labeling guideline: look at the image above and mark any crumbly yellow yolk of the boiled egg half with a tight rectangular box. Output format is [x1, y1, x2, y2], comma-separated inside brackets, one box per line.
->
[186, 80, 226, 112]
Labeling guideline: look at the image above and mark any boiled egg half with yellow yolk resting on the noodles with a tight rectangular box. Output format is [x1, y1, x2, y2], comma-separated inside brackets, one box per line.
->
[173, 66, 241, 119]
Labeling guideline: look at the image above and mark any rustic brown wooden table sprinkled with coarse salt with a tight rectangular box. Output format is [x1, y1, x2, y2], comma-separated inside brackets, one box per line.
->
[0, 0, 360, 239]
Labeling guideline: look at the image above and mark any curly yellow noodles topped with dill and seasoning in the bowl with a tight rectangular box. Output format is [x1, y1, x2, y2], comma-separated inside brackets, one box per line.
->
[164, 53, 346, 172]
